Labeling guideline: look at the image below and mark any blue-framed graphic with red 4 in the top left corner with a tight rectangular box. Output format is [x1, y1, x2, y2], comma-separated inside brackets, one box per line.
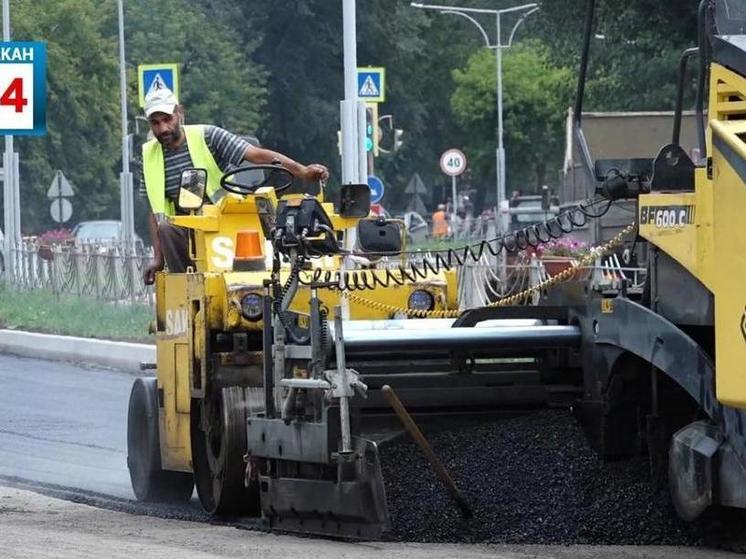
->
[0, 41, 47, 136]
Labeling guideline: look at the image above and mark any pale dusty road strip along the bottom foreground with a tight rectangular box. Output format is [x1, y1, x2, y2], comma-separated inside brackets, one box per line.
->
[0, 487, 736, 559]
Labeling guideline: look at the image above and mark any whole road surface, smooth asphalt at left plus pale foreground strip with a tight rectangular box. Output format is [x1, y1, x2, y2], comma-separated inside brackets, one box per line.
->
[0, 355, 731, 559]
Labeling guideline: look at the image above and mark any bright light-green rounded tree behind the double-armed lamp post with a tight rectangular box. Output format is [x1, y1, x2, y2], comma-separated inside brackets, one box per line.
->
[451, 40, 573, 197]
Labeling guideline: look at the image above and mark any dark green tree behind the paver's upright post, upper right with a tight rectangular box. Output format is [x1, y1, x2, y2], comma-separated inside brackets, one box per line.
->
[524, 0, 698, 111]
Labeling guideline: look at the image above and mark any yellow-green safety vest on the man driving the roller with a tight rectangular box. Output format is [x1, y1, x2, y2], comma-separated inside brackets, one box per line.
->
[142, 124, 223, 216]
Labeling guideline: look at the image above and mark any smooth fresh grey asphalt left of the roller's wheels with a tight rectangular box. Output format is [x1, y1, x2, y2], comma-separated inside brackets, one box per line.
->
[0, 355, 134, 499]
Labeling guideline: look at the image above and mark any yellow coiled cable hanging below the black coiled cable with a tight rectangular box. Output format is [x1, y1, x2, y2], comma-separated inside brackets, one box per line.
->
[342, 223, 637, 318]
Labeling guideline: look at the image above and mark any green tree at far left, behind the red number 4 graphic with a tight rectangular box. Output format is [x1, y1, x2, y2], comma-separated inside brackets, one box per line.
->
[11, 0, 119, 234]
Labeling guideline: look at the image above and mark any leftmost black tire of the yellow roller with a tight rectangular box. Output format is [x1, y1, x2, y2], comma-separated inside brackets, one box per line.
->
[127, 378, 194, 502]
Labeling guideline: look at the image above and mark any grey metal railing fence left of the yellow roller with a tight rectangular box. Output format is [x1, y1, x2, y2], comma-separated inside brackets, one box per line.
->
[4, 240, 154, 303]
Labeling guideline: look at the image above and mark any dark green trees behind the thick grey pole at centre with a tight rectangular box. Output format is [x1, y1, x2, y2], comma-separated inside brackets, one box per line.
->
[243, 0, 478, 209]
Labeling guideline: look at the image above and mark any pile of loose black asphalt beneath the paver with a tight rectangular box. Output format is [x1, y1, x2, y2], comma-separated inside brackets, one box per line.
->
[381, 410, 732, 545]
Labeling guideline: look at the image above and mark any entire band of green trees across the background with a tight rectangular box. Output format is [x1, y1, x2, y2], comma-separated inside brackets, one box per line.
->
[0, 0, 708, 234]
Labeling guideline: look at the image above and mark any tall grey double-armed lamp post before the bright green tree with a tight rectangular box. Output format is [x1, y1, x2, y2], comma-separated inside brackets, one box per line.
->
[411, 2, 539, 234]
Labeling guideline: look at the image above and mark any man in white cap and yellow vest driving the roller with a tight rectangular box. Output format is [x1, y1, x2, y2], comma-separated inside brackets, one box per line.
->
[141, 88, 329, 285]
